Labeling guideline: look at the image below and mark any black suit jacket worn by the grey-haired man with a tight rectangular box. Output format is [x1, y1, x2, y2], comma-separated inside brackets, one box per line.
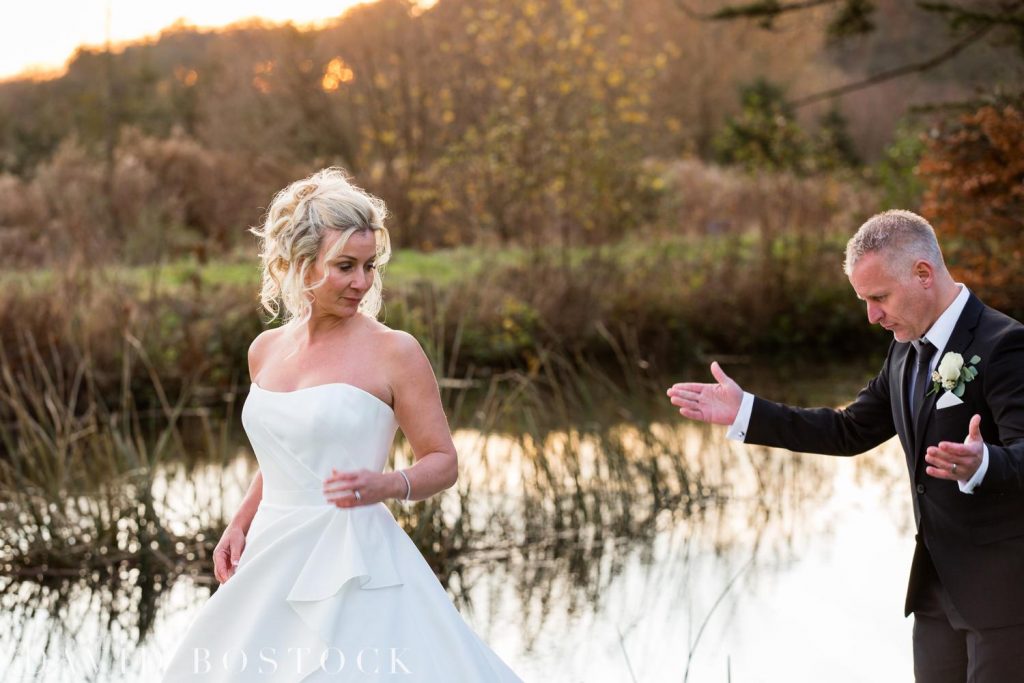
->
[744, 295, 1024, 629]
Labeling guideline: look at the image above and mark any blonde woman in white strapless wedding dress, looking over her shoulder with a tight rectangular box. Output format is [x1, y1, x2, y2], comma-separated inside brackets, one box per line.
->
[164, 169, 519, 683]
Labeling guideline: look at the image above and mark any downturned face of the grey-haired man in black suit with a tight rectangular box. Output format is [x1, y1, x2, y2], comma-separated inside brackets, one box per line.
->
[850, 252, 931, 342]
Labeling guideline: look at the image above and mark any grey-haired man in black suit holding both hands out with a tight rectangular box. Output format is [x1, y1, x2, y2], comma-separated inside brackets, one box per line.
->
[669, 211, 1024, 683]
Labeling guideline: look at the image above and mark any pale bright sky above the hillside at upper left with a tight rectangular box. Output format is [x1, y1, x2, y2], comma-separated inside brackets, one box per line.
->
[0, 0, 376, 79]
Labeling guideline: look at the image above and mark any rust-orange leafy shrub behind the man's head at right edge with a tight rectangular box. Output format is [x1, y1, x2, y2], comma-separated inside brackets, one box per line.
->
[919, 100, 1024, 317]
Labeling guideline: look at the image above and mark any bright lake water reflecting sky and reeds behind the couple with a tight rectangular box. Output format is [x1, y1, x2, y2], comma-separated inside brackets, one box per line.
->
[0, 411, 911, 681]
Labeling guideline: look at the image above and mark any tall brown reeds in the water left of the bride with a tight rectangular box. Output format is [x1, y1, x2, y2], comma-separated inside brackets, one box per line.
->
[0, 336, 233, 577]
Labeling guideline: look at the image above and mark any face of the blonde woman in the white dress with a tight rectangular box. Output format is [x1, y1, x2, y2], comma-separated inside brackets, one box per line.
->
[309, 230, 377, 317]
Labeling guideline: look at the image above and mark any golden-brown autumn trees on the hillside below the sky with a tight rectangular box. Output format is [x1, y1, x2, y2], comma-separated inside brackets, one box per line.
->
[0, 0, 830, 266]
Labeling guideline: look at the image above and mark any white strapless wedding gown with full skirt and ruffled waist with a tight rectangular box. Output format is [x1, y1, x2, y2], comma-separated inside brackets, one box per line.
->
[164, 383, 519, 683]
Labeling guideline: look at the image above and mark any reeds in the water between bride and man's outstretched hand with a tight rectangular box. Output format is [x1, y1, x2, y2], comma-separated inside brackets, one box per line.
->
[394, 336, 718, 575]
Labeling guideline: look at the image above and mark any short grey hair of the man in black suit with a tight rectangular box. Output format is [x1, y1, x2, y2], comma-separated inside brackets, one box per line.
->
[843, 209, 945, 278]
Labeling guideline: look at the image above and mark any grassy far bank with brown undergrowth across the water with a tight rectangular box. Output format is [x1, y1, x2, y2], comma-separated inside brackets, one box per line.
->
[0, 232, 885, 405]
